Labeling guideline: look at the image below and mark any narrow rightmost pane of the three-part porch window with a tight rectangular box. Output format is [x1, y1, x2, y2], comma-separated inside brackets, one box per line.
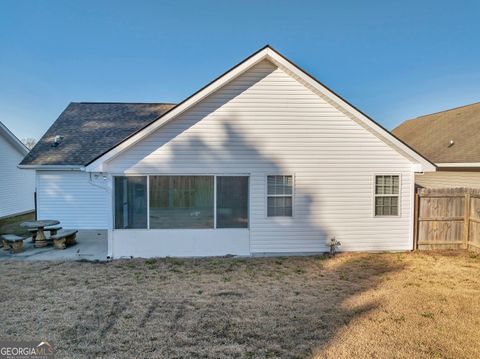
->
[217, 176, 248, 228]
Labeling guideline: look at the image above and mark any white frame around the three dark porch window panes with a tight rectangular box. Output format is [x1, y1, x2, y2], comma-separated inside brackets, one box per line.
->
[110, 172, 251, 231]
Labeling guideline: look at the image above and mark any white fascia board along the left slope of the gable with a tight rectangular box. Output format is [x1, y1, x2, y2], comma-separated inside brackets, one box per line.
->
[86, 48, 268, 172]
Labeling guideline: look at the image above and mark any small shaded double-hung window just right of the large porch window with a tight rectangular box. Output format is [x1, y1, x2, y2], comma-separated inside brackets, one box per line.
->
[267, 176, 293, 217]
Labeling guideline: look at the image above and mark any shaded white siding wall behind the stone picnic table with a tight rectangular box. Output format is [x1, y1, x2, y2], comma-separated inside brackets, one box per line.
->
[37, 171, 112, 229]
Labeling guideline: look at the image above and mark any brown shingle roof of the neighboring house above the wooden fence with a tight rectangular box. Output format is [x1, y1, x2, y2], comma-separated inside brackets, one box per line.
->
[392, 102, 480, 166]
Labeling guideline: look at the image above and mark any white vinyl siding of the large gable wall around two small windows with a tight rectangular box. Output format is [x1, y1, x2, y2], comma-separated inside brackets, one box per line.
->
[106, 61, 413, 253]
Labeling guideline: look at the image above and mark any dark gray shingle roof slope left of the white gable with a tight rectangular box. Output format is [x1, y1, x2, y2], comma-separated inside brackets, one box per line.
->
[20, 102, 175, 166]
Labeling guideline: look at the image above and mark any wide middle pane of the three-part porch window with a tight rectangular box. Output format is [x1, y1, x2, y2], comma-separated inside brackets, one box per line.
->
[150, 176, 214, 228]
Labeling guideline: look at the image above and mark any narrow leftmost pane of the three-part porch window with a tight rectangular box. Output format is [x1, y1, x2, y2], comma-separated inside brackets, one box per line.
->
[115, 176, 147, 229]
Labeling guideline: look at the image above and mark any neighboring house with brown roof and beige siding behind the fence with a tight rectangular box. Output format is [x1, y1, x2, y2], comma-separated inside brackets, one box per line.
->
[392, 103, 480, 188]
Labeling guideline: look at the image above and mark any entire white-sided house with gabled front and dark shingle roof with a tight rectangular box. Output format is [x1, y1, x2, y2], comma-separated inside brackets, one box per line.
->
[21, 46, 435, 258]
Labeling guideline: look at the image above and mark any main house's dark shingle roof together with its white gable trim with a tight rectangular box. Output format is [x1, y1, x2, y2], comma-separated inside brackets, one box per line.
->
[21, 45, 435, 172]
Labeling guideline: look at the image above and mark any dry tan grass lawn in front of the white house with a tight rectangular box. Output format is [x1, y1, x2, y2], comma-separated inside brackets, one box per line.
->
[0, 252, 480, 358]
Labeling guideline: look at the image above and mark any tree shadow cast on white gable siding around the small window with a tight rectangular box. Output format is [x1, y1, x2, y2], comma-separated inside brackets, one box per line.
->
[157, 118, 335, 253]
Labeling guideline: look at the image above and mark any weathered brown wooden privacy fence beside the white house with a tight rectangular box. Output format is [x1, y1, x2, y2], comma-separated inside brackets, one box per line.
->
[414, 188, 480, 250]
